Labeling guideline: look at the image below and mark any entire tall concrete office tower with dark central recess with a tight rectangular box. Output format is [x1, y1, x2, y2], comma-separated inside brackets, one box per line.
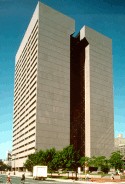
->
[12, 2, 114, 169]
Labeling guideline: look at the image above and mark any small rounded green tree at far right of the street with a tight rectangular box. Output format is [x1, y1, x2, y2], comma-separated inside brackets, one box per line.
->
[109, 151, 124, 170]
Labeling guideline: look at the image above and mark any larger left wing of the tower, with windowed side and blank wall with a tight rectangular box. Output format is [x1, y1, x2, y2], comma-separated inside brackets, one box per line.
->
[12, 3, 74, 168]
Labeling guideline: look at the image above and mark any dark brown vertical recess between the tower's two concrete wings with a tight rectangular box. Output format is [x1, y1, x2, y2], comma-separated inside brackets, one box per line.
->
[70, 35, 88, 156]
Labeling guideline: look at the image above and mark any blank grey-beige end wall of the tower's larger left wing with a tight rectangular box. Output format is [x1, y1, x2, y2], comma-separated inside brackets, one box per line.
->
[36, 3, 74, 149]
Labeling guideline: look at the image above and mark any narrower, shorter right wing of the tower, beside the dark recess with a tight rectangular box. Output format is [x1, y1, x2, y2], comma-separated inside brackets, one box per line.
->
[80, 26, 114, 157]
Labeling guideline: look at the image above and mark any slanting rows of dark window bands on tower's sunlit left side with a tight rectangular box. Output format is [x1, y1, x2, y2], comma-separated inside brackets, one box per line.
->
[13, 21, 38, 154]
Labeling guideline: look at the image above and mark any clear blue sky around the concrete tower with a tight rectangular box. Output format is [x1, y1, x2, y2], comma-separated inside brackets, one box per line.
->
[0, 0, 125, 159]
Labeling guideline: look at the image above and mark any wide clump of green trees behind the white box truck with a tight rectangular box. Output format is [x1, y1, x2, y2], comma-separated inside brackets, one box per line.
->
[24, 145, 80, 172]
